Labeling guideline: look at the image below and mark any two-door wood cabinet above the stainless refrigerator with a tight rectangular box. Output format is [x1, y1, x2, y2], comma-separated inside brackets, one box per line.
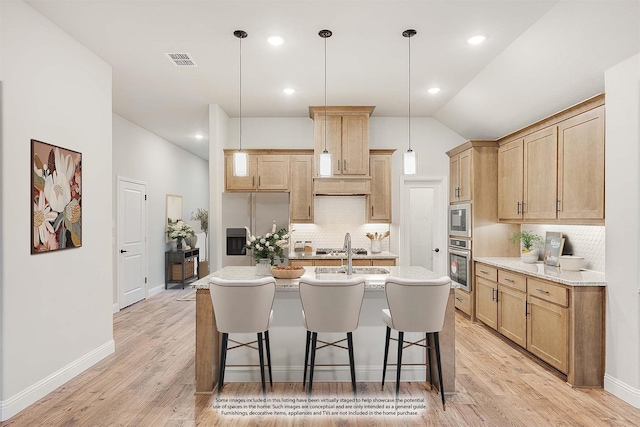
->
[224, 153, 289, 192]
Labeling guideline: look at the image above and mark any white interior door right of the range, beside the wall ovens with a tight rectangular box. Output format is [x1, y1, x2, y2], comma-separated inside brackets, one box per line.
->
[400, 176, 447, 275]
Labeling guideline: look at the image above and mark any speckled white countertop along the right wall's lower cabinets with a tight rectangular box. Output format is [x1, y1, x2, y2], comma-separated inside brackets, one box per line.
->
[474, 257, 607, 286]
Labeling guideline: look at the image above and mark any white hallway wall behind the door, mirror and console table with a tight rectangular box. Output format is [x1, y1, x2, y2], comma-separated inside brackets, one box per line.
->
[113, 114, 209, 304]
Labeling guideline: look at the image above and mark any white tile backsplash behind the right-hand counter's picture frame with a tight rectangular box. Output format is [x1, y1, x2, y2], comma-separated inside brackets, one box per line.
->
[521, 224, 605, 273]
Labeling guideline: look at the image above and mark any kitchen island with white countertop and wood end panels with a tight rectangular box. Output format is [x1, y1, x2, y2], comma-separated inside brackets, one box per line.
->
[193, 266, 455, 394]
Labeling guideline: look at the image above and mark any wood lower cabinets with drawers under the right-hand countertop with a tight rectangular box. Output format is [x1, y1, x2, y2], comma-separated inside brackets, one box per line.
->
[475, 263, 605, 387]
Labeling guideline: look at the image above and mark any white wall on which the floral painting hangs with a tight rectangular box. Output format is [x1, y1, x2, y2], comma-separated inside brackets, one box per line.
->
[0, 1, 114, 420]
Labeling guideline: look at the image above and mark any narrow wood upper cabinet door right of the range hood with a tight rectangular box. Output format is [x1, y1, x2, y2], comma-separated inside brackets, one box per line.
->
[367, 155, 391, 223]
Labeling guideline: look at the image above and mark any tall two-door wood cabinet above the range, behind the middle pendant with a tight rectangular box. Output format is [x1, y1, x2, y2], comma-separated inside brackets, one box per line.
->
[309, 107, 375, 176]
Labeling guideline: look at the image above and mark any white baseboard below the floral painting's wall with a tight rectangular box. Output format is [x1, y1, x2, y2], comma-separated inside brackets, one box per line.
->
[0, 340, 115, 421]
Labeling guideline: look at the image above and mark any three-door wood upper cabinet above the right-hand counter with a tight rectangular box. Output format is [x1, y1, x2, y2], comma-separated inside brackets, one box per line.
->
[498, 97, 605, 223]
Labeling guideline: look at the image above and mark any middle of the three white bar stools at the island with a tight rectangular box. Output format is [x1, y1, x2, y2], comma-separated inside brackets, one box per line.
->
[300, 277, 365, 394]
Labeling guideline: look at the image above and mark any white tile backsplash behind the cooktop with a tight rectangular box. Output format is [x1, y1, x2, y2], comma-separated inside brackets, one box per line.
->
[291, 196, 394, 252]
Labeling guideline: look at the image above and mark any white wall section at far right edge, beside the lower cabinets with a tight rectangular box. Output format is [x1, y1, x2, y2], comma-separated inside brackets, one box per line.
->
[605, 55, 640, 408]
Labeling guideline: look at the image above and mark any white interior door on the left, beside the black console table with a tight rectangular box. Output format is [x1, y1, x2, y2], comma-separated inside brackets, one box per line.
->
[117, 177, 147, 309]
